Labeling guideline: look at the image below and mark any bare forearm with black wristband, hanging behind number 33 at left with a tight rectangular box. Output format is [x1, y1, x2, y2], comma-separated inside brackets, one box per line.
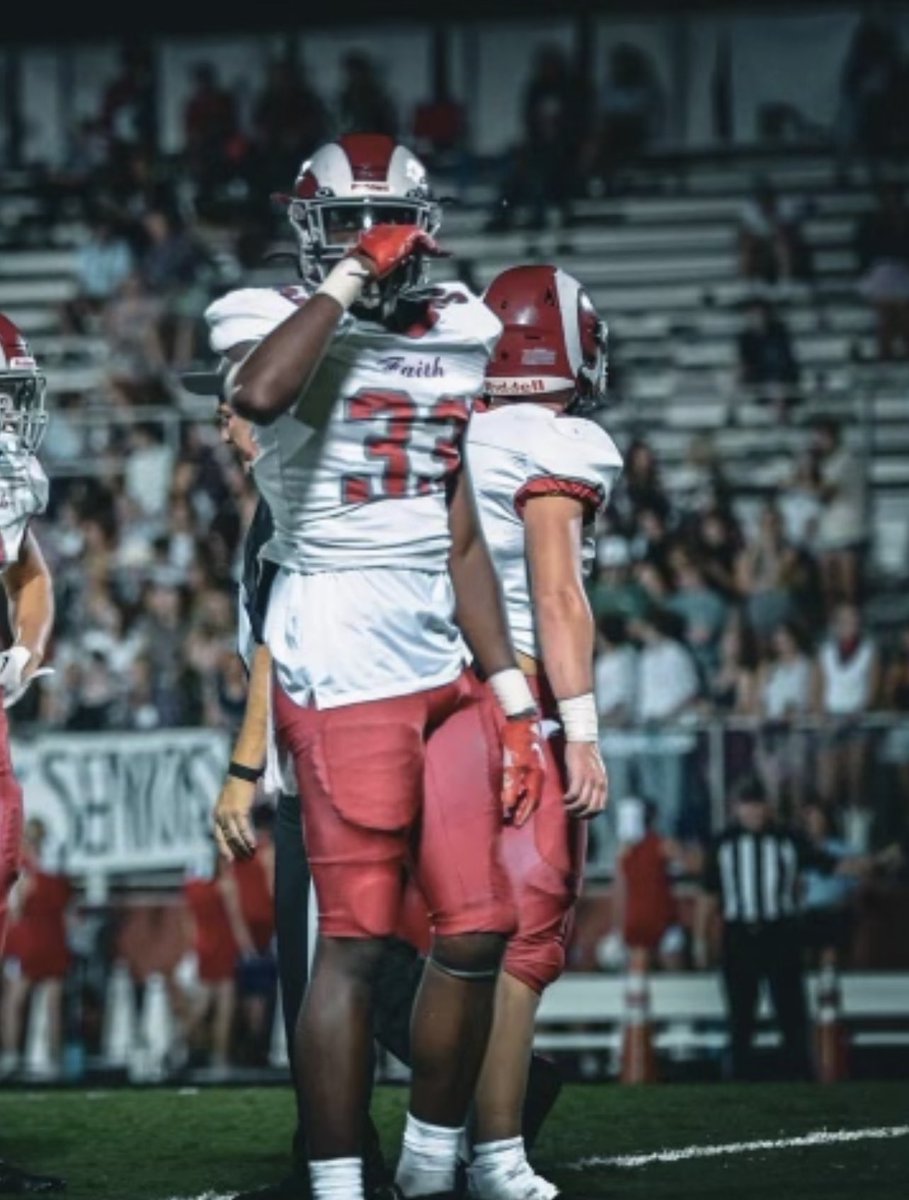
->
[213, 646, 271, 859]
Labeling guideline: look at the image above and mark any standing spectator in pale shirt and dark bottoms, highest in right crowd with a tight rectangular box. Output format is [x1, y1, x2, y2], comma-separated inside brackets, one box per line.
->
[813, 418, 868, 606]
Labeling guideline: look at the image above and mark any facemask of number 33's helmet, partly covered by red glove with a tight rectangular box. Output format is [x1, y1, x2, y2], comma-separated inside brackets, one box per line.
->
[288, 194, 441, 316]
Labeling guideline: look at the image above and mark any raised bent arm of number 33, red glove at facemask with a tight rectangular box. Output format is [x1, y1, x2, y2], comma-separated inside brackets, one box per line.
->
[225, 226, 441, 425]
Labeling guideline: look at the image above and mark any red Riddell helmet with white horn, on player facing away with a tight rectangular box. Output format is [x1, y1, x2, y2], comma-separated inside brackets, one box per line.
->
[483, 266, 607, 413]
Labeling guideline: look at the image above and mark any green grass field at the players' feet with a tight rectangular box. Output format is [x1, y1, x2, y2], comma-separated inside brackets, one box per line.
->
[0, 1084, 909, 1200]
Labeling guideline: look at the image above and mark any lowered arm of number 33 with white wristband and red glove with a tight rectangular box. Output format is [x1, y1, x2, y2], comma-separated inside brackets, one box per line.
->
[449, 468, 543, 826]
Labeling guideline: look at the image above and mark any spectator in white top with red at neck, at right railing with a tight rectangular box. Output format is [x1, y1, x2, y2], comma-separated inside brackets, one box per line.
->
[814, 604, 880, 846]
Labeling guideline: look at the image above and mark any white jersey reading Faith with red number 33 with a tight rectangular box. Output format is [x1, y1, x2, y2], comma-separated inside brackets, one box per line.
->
[206, 284, 501, 708]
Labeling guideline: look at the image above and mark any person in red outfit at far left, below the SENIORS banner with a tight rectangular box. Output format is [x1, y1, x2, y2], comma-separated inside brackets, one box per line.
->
[0, 817, 73, 1075]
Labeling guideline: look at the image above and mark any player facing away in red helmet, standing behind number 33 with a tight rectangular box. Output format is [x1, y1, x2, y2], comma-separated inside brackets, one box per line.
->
[466, 266, 621, 1200]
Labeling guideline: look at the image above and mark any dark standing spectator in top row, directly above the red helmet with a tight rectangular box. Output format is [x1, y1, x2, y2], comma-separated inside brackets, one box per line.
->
[487, 44, 584, 232]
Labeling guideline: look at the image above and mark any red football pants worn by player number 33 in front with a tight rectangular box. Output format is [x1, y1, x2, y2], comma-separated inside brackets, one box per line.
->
[273, 671, 514, 938]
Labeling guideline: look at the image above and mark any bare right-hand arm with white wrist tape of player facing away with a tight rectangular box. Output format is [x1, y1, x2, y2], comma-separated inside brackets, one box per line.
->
[524, 496, 608, 817]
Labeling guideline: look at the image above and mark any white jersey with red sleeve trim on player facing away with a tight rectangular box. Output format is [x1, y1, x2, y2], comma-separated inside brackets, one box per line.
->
[468, 403, 621, 658]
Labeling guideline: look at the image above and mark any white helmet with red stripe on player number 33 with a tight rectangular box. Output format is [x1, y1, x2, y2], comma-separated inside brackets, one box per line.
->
[283, 133, 441, 292]
